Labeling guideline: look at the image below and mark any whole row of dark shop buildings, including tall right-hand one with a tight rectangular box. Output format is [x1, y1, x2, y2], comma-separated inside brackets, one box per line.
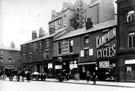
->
[21, 0, 135, 81]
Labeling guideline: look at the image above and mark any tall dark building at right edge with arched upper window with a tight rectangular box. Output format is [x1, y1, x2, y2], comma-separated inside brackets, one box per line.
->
[117, 0, 135, 81]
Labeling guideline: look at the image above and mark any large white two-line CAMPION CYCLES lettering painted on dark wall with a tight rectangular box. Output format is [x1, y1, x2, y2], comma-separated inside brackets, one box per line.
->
[96, 27, 116, 58]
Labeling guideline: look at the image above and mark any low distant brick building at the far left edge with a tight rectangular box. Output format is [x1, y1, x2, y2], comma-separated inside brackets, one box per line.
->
[0, 47, 21, 70]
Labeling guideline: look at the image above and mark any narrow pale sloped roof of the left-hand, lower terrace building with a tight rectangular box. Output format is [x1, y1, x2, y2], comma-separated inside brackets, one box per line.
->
[21, 28, 65, 45]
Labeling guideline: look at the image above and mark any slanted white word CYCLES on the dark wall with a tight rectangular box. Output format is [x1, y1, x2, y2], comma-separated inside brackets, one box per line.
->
[97, 44, 116, 58]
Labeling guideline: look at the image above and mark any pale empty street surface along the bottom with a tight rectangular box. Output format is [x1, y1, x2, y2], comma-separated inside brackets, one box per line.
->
[0, 79, 135, 91]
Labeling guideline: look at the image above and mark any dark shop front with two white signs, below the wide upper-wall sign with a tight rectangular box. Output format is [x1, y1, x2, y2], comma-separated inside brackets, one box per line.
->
[54, 54, 78, 79]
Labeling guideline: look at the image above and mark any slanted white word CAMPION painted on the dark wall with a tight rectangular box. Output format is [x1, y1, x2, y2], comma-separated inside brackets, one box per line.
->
[96, 27, 116, 48]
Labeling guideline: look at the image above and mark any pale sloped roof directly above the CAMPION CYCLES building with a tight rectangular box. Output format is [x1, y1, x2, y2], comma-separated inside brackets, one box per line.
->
[56, 20, 117, 40]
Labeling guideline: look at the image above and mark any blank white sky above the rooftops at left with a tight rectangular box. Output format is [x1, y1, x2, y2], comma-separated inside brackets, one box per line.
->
[0, 0, 75, 47]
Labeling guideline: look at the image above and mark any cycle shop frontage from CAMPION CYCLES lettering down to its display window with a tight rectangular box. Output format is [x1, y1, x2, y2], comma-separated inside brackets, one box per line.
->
[96, 27, 118, 81]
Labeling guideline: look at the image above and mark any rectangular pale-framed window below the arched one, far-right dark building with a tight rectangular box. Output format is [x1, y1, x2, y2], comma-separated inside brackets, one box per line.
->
[128, 32, 135, 48]
